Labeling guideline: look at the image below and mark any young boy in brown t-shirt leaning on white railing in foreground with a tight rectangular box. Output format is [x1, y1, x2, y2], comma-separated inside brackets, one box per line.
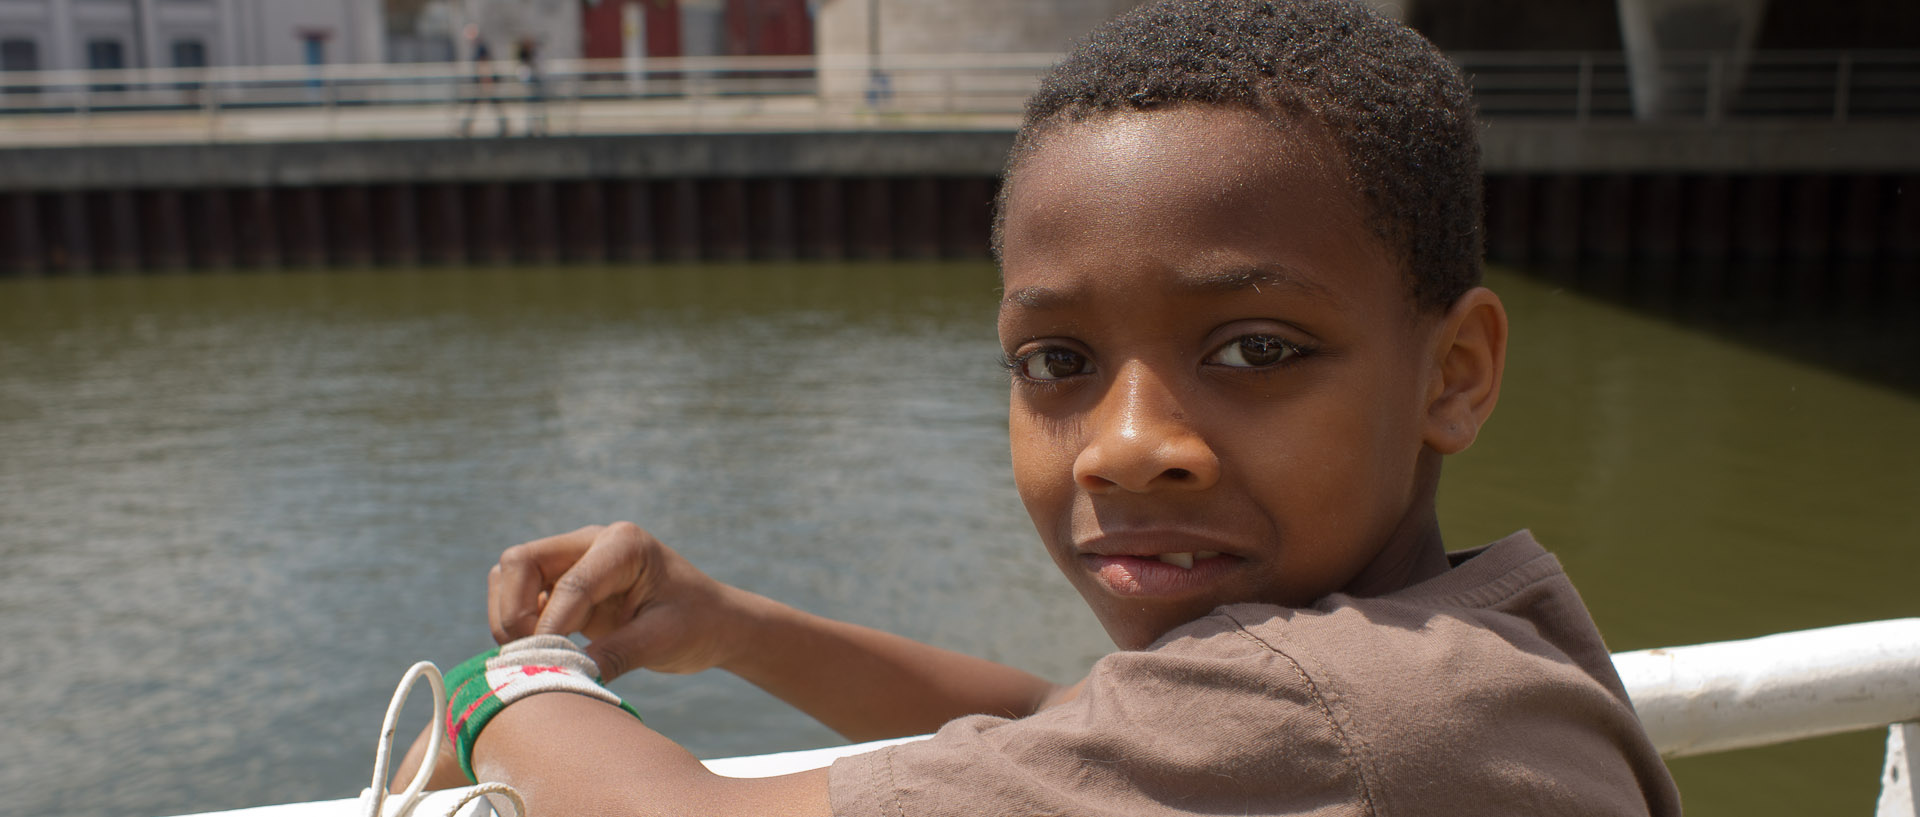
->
[393, 0, 1678, 817]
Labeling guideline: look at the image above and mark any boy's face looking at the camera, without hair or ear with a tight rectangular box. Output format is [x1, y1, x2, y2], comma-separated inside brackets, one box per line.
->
[998, 105, 1440, 648]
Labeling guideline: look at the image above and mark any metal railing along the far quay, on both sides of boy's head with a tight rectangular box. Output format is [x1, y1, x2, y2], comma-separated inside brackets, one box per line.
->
[0, 52, 1920, 144]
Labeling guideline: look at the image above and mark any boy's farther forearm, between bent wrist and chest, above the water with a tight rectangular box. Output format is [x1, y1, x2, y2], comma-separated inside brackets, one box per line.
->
[722, 596, 1066, 740]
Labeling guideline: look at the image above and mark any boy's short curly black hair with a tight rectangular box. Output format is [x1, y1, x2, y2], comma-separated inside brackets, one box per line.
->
[993, 0, 1482, 311]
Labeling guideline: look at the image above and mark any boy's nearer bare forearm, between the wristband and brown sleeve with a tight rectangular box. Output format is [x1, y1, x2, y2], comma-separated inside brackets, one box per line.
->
[474, 692, 829, 817]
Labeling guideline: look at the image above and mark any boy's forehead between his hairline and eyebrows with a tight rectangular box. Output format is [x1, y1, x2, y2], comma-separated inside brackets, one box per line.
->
[1002, 105, 1402, 322]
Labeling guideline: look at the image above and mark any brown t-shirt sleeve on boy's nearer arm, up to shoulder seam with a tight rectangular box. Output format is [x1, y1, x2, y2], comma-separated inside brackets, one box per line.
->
[829, 618, 1369, 817]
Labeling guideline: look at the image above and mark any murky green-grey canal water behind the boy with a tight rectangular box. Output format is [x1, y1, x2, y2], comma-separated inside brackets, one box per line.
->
[0, 265, 1920, 815]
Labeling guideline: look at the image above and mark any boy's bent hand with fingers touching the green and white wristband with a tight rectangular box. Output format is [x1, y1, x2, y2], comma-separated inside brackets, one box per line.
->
[488, 522, 751, 681]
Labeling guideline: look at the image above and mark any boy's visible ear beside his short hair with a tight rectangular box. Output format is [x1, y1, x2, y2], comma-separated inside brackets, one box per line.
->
[1425, 286, 1507, 455]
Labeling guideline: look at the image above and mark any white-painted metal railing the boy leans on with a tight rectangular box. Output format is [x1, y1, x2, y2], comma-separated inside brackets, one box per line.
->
[168, 618, 1920, 817]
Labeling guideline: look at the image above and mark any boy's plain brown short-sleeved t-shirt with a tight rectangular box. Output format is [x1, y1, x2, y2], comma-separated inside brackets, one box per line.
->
[829, 531, 1680, 817]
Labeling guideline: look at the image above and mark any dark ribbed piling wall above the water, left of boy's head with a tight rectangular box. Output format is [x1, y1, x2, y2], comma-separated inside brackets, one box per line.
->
[0, 176, 998, 274]
